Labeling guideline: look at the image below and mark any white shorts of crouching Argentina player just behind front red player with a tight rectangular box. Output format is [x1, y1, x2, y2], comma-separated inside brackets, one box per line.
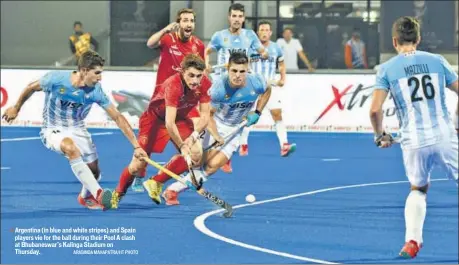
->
[201, 119, 242, 159]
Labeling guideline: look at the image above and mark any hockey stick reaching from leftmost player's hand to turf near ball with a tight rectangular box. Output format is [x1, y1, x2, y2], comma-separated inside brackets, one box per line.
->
[144, 157, 233, 218]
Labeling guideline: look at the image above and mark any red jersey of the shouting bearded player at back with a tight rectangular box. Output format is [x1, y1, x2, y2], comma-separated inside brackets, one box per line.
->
[154, 32, 205, 88]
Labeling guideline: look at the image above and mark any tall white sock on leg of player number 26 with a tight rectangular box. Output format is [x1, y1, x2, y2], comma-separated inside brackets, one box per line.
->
[405, 190, 427, 245]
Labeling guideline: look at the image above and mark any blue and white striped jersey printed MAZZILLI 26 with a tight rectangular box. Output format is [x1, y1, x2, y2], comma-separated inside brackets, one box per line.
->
[375, 51, 458, 149]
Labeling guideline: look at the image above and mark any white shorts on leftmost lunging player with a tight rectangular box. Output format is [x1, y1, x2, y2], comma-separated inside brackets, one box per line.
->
[40, 128, 97, 163]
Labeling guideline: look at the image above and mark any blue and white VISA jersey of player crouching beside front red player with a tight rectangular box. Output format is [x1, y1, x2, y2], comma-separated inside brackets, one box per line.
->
[209, 73, 267, 125]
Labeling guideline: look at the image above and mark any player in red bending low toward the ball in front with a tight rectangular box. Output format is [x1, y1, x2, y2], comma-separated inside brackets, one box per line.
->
[112, 54, 211, 208]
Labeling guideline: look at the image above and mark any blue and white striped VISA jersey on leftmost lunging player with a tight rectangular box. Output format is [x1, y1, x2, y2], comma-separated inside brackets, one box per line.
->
[39, 71, 110, 128]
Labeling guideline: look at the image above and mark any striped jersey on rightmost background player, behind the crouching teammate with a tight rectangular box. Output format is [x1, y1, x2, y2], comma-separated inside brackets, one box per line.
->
[250, 41, 284, 81]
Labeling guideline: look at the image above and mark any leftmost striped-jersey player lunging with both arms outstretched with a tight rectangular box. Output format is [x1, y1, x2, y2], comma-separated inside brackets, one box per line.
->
[3, 51, 146, 209]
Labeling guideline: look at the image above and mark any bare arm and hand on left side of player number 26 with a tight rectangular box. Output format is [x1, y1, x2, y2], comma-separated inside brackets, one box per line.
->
[370, 89, 392, 148]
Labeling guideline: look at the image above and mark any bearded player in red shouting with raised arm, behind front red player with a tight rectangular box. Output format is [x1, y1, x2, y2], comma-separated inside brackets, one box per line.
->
[132, 8, 205, 192]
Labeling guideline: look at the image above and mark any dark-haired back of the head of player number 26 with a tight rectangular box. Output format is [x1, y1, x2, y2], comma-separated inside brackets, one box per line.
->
[392, 17, 421, 45]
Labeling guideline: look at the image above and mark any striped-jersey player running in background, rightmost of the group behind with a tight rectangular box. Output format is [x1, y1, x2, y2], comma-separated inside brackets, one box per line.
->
[239, 21, 296, 156]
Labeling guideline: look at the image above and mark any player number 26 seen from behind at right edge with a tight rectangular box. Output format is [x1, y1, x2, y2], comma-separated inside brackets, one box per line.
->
[370, 17, 458, 258]
